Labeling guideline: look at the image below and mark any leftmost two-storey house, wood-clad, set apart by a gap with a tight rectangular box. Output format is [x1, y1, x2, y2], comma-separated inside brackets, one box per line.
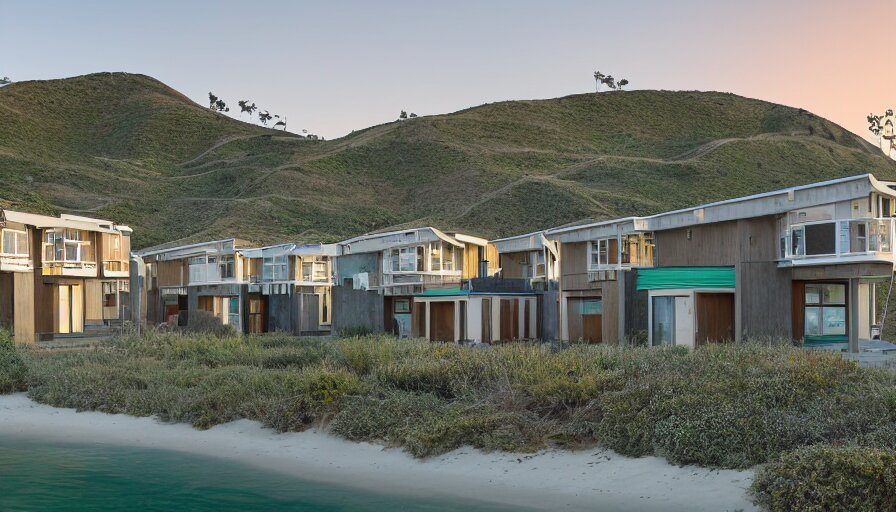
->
[0, 210, 131, 343]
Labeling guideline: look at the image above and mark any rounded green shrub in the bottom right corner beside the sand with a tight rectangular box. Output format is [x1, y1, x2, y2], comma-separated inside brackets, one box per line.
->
[751, 444, 896, 512]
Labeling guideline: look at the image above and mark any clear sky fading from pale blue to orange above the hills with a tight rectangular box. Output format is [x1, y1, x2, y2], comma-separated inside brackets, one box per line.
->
[0, 0, 896, 142]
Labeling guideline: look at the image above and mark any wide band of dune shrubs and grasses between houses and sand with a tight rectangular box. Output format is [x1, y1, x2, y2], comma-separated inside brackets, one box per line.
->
[0, 332, 896, 510]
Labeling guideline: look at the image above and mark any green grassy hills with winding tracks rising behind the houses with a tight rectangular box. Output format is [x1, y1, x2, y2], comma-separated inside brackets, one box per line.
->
[0, 73, 896, 246]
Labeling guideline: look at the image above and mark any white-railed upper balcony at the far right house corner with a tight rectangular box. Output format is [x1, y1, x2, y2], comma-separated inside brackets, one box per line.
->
[778, 218, 896, 266]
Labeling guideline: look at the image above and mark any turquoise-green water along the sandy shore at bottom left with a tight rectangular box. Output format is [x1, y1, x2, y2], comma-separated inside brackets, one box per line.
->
[0, 437, 518, 512]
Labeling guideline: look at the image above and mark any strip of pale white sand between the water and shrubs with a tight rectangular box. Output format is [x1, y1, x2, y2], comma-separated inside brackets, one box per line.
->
[0, 393, 756, 512]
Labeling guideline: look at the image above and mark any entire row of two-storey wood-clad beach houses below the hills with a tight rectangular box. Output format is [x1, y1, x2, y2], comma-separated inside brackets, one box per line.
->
[0, 175, 896, 351]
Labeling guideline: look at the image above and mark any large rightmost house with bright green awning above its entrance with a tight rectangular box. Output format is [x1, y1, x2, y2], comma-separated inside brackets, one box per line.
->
[546, 175, 896, 351]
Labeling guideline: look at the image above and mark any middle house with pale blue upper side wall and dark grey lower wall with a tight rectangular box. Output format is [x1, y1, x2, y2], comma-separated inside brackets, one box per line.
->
[334, 227, 497, 341]
